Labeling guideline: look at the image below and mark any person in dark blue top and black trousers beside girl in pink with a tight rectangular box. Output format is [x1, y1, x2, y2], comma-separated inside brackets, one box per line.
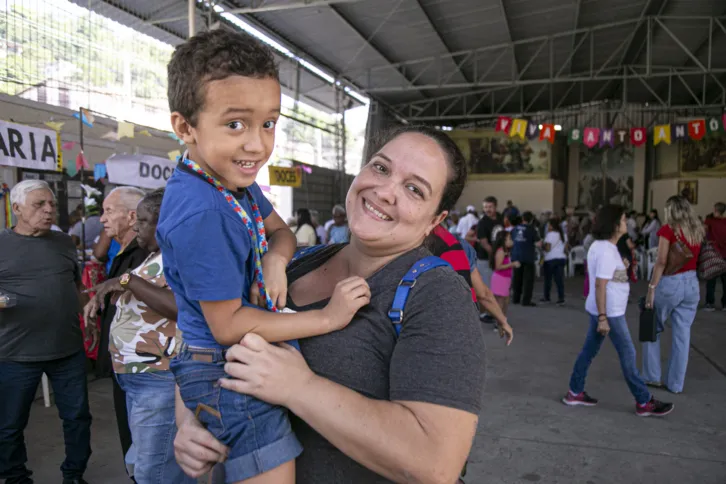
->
[512, 212, 541, 306]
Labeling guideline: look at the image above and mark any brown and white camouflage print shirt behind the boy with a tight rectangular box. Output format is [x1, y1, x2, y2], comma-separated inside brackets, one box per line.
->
[109, 251, 179, 373]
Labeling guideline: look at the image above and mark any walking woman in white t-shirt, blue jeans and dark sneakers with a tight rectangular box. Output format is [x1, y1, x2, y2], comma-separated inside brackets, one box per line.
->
[562, 205, 673, 417]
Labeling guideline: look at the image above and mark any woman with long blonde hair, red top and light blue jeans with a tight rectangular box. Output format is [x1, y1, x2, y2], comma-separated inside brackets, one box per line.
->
[643, 195, 706, 393]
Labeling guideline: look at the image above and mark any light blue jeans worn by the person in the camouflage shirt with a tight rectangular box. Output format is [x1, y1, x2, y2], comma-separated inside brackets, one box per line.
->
[116, 371, 196, 484]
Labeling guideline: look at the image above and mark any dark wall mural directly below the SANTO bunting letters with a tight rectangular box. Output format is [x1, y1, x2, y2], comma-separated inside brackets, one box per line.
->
[577, 145, 635, 210]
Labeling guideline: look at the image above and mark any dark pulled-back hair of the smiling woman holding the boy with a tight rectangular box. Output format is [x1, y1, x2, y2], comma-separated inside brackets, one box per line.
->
[371, 125, 467, 214]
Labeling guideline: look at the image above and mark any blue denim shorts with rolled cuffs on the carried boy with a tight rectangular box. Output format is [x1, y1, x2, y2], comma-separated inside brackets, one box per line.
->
[170, 343, 302, 482]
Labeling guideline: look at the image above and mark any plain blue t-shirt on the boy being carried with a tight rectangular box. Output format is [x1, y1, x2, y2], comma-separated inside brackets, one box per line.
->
[156, 164, 272, 348]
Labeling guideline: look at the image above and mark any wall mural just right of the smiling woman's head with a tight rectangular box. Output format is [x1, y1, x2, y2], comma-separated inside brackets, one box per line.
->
[449, 130, 552, 178]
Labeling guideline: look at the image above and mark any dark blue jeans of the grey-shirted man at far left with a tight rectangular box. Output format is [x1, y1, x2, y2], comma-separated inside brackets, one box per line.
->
[0, 350, 91, 484]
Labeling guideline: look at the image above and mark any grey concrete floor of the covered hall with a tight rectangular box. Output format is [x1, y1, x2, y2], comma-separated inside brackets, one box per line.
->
[26, 278, 726, 484]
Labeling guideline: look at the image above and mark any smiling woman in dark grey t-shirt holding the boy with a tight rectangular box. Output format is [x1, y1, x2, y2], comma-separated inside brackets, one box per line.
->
[175, 126, 484, 484]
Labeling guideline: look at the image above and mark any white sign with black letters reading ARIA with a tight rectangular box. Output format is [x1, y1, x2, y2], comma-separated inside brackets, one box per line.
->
[0, 121, 59, 171]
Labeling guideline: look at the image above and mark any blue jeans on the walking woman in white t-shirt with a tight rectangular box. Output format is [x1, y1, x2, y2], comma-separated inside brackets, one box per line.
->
[570, 314, 650, 405]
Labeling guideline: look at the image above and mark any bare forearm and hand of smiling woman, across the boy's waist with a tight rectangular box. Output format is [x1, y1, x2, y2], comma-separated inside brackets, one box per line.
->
[222, 334, 478, 483]
